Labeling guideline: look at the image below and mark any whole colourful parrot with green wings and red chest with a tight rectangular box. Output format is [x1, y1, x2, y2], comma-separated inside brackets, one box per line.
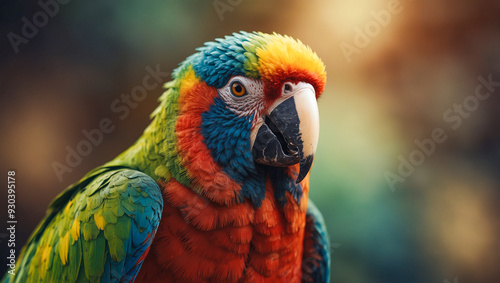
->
[3, 31, 331, 283]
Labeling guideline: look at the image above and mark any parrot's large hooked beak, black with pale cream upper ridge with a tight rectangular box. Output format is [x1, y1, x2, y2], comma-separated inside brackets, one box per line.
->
[251, 82, 319, 183]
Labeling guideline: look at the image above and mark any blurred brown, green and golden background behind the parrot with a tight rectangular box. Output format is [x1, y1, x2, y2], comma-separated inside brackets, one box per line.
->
[0, 0, 500, 283]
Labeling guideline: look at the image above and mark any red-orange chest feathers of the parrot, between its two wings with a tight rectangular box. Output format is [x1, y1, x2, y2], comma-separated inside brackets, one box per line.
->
[136, 178, 309, 282]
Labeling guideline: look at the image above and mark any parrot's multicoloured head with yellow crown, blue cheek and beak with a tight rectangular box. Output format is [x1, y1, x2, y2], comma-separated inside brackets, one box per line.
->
[158, 32, 326, 206]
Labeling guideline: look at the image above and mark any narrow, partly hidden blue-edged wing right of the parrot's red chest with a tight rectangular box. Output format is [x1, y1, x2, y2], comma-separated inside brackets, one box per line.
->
[302, 199, 330, 282]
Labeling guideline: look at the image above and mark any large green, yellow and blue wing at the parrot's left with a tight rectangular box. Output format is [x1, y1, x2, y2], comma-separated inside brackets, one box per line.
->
[11, 169, 163, 282]
